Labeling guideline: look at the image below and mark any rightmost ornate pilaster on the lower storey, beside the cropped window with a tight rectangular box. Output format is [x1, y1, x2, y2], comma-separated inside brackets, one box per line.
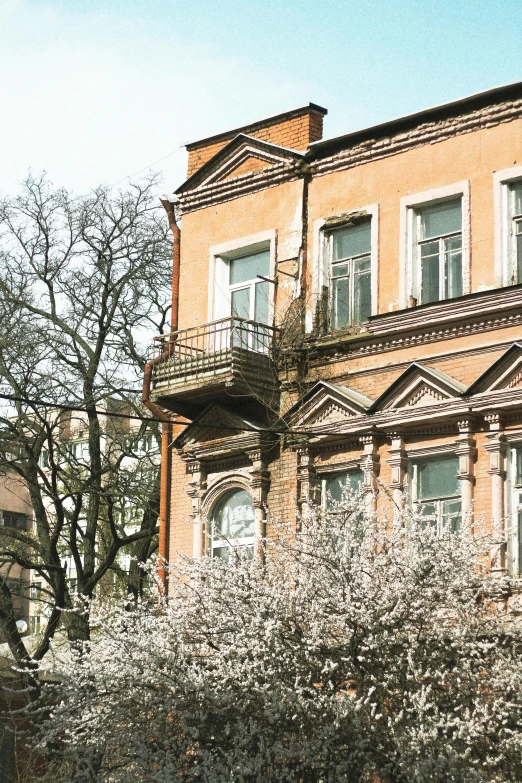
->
[484, 413, 507, 575]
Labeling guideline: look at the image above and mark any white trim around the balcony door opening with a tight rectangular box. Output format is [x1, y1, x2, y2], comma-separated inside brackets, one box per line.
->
[208, 228, 277, 325]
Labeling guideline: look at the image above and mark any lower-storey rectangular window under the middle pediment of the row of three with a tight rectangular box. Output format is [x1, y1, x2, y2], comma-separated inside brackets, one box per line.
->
[412, 456, 462, 534]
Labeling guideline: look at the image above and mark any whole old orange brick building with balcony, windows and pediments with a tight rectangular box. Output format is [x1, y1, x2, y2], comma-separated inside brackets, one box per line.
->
[152, 83, 522, 574]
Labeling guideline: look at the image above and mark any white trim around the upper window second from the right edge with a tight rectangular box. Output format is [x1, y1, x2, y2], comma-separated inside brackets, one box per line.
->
[399, 180, 471, 309]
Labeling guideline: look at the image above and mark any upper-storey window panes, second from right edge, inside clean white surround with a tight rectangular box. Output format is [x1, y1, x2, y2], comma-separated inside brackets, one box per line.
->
[416, 198, 462, 304]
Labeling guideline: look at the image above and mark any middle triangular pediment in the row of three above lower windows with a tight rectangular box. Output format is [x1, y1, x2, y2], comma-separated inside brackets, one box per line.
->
[371, 363, 466, 413]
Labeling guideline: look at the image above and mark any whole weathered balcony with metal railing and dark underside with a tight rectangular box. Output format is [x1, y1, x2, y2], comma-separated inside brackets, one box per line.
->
[152, 318, 278, 418]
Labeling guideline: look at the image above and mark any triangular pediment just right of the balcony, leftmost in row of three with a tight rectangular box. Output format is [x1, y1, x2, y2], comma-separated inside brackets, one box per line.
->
[284, 381, 372, 431]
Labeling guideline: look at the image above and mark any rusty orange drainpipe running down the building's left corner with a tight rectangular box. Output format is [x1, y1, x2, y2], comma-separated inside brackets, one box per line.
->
[141, 199, 181, 592]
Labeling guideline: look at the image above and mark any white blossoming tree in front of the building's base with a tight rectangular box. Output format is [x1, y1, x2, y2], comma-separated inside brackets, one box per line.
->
[35, 494, 522, 783]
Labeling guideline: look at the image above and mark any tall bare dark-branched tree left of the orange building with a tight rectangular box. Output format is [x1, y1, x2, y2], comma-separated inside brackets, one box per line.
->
[0, 176, 172, 660]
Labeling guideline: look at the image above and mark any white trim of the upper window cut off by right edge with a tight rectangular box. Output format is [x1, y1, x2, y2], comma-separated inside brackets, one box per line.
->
[493, 166, 522, 287]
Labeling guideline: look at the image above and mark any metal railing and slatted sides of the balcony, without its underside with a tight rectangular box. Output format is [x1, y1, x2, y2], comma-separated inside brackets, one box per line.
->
[153, 317, 278, 402]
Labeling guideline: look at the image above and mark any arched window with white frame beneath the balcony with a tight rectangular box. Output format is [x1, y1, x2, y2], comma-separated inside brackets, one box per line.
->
[210, 489, 254, 561]
